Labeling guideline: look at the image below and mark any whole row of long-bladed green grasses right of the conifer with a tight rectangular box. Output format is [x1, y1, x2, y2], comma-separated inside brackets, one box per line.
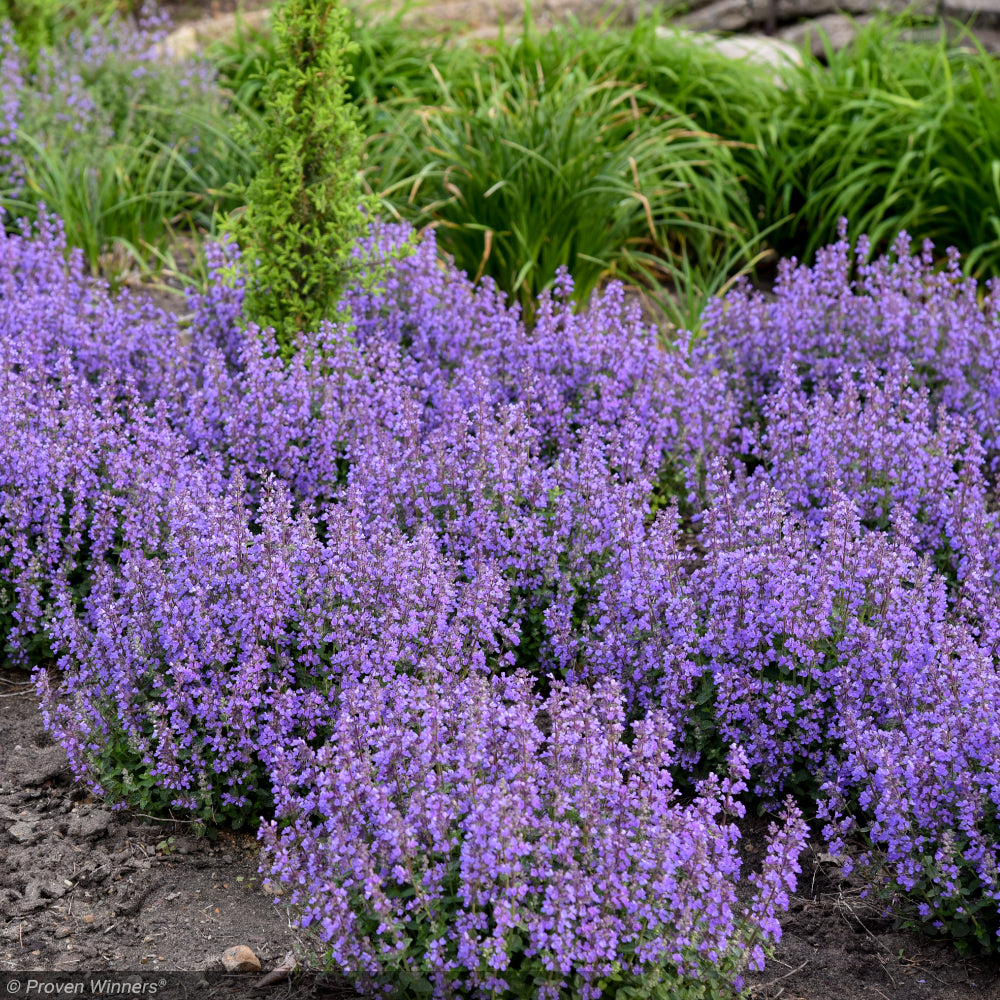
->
[145, 7, 1000, 320]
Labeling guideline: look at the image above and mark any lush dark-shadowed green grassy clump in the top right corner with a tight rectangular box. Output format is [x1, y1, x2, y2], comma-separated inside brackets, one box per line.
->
[741, 18, 1000, 276]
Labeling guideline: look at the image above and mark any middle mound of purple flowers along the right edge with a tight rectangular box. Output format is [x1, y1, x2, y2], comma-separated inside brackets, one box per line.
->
[751, 357, 1000, 632]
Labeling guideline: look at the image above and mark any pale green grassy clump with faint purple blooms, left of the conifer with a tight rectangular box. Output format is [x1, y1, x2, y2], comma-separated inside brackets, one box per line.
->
[0, 14, 253, 284]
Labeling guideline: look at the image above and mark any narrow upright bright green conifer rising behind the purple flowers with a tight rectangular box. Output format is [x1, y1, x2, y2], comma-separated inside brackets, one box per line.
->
[227, 0, 372, 350]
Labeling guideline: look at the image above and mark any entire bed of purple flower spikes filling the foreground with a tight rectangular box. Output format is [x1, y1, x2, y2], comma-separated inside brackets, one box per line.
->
[0, 197, 1000, 976]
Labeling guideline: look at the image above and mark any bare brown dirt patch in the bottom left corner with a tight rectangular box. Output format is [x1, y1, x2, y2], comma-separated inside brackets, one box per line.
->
[0, 671, 351, 997]
